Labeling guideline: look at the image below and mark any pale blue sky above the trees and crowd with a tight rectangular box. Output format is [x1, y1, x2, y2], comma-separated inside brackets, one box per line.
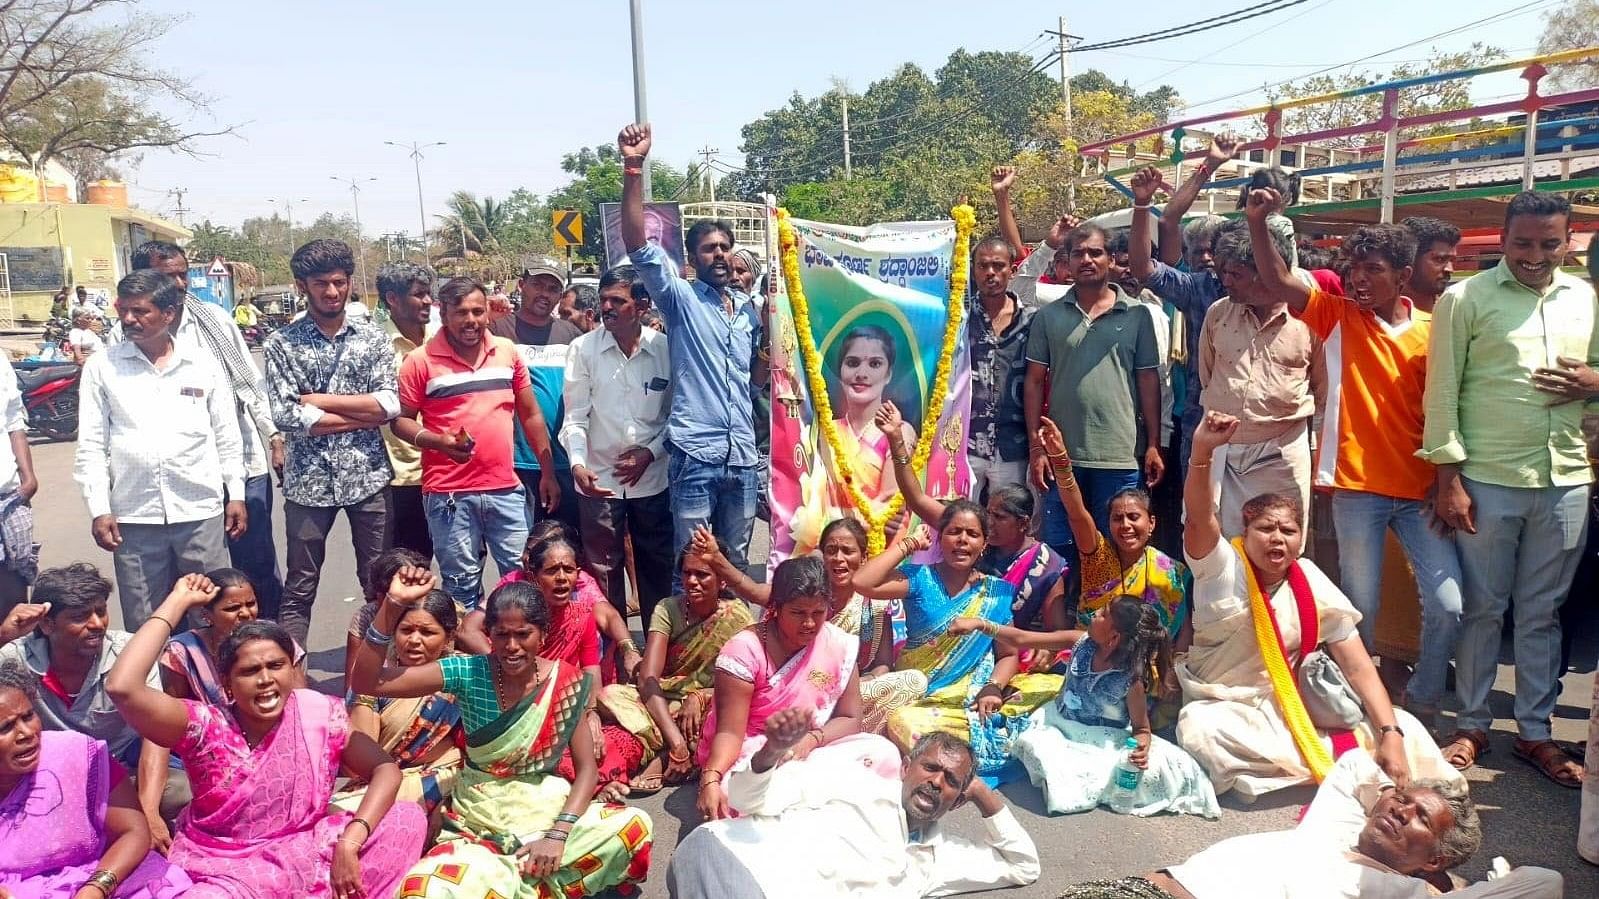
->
[128, 0, 1557, 235]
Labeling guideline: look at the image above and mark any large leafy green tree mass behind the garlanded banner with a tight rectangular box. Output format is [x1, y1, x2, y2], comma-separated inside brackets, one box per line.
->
[728, 50, 1182, 226]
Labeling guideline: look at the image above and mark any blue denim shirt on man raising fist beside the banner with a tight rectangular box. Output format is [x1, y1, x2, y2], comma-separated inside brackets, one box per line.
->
[628, 243, 761, 467]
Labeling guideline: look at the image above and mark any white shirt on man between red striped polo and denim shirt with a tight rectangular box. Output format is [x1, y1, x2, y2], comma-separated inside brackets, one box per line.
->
[560, 328, 672, 497]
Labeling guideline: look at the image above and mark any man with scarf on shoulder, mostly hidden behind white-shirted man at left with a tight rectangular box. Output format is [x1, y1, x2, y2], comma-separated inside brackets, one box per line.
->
[127, 240, 283, 619]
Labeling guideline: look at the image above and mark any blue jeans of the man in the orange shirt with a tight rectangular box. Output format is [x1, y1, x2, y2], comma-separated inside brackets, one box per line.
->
[1332, 489, 1461, 710]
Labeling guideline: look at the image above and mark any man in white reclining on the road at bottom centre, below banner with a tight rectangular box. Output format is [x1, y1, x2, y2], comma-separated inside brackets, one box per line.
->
[667, 709, 1039, 899]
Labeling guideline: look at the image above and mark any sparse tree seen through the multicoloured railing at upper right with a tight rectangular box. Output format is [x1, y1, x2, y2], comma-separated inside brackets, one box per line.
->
[1260, 43, 1505, 147]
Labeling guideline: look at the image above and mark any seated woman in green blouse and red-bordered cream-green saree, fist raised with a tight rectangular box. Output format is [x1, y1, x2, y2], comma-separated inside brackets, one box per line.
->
[352, 568, 651, 899]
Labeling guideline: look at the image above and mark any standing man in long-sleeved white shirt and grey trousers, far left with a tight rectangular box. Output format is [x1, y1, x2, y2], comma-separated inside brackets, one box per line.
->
[74, 269, 248, 630]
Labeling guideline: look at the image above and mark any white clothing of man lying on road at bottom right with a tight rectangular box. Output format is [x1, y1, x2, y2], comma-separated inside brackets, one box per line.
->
[1167, 749, 1562, 899]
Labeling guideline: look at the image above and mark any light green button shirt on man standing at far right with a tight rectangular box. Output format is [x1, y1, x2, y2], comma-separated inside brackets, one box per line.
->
[1417, 261, 1599, 488]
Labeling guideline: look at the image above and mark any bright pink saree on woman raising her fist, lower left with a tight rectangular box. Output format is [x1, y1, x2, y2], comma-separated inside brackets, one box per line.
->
[168, 689, 427, 899]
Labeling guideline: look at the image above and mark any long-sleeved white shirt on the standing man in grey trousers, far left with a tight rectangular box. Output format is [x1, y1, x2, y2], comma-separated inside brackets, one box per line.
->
[72, 341, 245, 525]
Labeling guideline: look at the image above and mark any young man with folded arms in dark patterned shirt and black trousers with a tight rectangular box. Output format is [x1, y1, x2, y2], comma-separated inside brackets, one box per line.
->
[265, 240, 400, 643]
